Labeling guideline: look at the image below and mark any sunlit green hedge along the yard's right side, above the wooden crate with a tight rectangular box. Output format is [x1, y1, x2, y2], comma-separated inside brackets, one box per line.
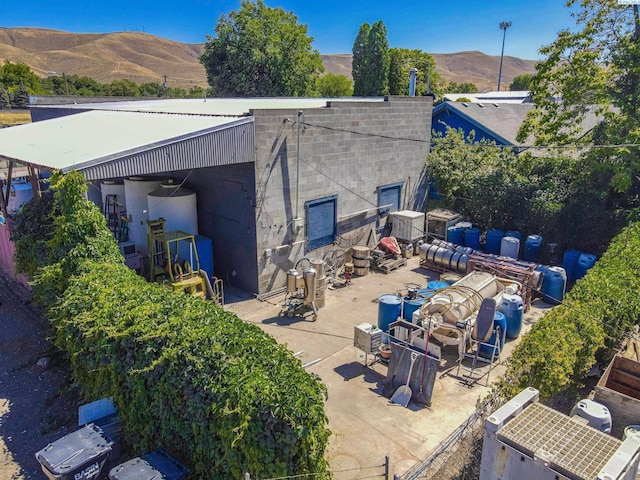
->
[499, 223, 640, 398]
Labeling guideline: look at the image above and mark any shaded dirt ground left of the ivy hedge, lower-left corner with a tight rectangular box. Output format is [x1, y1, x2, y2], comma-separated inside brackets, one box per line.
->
[0, 272, 79, 480]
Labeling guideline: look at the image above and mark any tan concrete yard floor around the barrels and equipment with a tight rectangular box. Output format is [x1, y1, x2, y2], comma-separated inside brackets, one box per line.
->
[226, 256, 548, 480]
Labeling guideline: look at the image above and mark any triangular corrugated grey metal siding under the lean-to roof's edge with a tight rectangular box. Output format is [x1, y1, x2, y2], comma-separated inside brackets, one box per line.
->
[75, 119, 255, 180]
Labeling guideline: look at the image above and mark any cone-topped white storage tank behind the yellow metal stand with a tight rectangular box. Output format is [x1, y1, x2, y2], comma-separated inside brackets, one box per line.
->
[147, 180, 198, 235]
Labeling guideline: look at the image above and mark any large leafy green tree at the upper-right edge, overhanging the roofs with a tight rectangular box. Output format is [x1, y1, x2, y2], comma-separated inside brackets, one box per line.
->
[518, 0, 640, 195]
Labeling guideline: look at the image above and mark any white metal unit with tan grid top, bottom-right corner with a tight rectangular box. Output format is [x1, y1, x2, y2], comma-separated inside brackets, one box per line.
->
[480, 388, 640, 480]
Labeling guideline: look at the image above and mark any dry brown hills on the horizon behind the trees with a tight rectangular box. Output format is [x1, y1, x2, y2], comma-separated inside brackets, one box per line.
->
[0, 28, 536, 91]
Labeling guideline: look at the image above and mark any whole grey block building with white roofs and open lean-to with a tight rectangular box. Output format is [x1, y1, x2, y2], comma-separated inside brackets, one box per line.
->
[0, 96, 433, 294]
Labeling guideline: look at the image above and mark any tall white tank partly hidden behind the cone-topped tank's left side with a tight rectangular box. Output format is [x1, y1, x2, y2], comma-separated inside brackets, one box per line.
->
[124, 177, 162, 255]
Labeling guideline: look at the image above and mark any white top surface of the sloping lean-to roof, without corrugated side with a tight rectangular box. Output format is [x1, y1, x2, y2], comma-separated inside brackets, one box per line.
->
[0, 110, 250, 171]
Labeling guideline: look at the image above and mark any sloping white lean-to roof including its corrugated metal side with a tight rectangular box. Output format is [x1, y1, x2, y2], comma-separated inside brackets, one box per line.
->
[0, 110, 255, 180]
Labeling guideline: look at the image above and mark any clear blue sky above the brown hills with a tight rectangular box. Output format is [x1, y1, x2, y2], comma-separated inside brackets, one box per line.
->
[0, 0, 574, 59]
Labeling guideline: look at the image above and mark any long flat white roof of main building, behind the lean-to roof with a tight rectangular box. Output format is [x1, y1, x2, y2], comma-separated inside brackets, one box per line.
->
[31, 97, 384, 116]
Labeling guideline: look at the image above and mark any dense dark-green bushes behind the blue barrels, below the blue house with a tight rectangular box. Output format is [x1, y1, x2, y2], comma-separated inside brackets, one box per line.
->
[427, 127, 633, 254]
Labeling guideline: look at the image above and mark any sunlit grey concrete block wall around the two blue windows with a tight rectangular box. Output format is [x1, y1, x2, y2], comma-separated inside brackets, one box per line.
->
[252, 97, 433, 293]
